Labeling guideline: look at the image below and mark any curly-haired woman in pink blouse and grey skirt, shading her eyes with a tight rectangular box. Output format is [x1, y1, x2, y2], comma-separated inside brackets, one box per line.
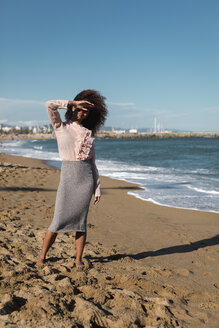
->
[36, 90, 107, 267]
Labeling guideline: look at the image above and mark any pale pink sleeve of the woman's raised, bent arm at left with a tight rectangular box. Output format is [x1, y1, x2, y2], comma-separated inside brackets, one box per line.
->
[46, 100, 69, 129]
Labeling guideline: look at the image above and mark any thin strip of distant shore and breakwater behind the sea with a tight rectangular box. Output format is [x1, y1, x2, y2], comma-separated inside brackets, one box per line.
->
[0, 131, 219, 141]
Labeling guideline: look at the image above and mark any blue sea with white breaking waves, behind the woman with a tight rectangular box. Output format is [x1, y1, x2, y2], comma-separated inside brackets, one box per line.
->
[0, 138, 219, 213]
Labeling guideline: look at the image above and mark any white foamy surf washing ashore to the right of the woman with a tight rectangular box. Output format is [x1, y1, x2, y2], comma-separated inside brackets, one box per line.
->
[97, 160, 218, 213]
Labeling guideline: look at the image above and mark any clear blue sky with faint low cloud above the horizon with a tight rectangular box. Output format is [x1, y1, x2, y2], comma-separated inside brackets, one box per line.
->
[0, 0, 219, 131]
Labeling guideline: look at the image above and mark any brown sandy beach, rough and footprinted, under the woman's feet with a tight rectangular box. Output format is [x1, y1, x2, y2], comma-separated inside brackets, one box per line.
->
[0, 154, 219, 328]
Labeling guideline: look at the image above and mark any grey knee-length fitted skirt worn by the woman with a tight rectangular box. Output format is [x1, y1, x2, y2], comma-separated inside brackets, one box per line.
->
[48, 160, 94, 232]
